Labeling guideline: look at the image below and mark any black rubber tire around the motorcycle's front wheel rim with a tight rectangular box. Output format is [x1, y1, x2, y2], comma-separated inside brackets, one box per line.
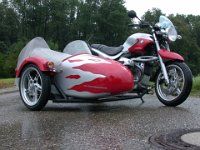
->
[155, 62, 193, 107]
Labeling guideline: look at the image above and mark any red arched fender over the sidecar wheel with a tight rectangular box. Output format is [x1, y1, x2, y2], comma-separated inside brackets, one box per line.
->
[15, 57, 49, 77]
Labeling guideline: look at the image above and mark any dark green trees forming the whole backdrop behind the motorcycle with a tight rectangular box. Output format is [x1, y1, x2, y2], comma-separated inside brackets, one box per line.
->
[0, 0, 200, 78]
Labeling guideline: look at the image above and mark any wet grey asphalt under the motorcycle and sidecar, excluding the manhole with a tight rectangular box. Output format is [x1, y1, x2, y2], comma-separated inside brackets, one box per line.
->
[0, 93, 200, 150]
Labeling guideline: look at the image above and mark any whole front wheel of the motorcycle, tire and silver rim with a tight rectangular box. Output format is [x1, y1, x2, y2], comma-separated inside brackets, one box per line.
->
[155, 62, 192, 106]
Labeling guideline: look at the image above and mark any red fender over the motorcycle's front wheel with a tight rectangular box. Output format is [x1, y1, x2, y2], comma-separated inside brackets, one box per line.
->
[158, 49, 184, 61]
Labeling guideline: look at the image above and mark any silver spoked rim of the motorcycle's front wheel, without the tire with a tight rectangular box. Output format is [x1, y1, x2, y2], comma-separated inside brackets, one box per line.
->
[156, 65, 185, 101]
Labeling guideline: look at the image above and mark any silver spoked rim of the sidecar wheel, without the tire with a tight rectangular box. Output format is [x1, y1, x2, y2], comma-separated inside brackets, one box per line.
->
[20, 67, 42, 106]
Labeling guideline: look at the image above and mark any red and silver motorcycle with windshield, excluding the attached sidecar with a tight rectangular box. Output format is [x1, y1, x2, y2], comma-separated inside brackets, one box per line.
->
[91, 11, 192, 106]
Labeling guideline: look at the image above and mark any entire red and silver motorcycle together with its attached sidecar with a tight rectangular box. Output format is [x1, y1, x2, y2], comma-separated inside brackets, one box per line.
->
[16, 11, 192, 111]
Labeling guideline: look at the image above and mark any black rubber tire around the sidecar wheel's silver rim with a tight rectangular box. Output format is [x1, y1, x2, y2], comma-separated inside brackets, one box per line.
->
[19, 64, 51, 111]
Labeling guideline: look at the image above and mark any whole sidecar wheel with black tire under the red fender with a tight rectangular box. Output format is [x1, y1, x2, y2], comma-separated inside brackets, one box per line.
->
[19, 64, 51, 111]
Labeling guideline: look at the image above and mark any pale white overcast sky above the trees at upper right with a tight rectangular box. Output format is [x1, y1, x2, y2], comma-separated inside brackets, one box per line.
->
[125, 0, 200, 17]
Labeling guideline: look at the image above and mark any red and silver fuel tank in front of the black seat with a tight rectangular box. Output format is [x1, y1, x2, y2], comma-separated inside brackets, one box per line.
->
[123, 33, 154, 55]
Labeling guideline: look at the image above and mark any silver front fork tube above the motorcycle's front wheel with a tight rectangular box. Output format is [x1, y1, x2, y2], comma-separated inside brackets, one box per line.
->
[153, 32, 169, 84]
